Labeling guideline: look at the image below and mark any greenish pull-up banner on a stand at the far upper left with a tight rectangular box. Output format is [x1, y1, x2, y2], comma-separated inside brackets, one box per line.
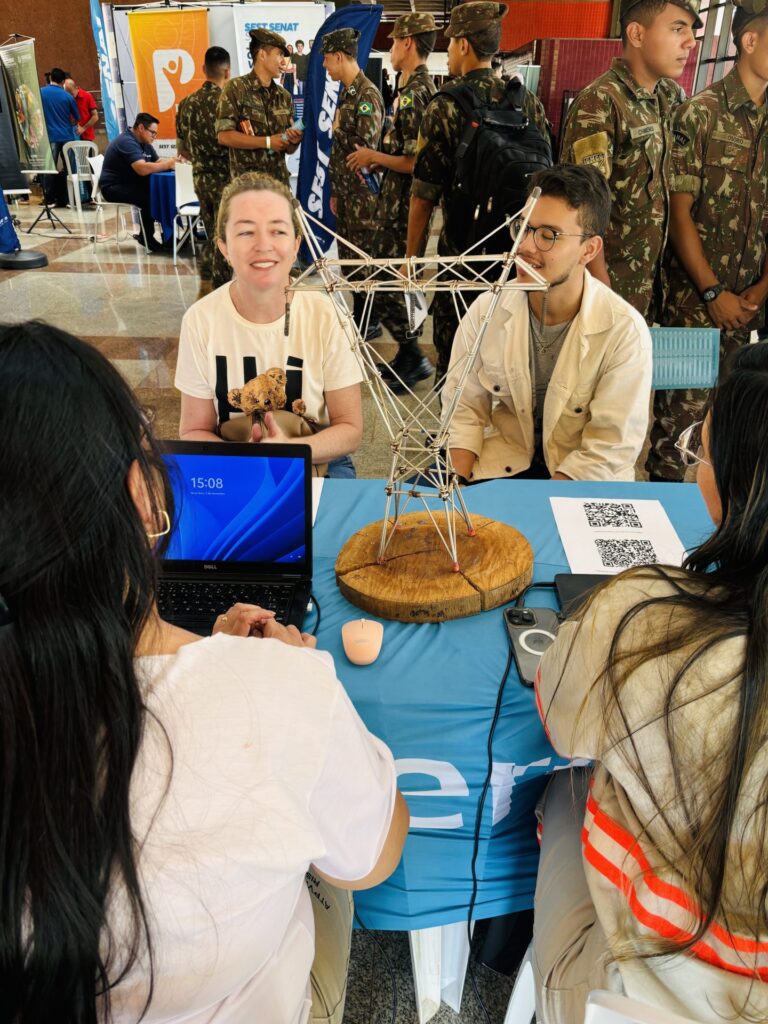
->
[0, 39, 55, 171]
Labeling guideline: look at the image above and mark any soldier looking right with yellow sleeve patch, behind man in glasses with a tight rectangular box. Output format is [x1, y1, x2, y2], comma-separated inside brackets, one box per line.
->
[560, 0, 701, 323]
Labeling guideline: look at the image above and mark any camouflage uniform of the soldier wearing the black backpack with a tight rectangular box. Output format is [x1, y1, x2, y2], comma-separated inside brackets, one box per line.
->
[411, 68, 549, 380]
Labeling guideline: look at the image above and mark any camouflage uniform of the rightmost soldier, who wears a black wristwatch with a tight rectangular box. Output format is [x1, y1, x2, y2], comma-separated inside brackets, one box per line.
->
[646, 68, 768, 479]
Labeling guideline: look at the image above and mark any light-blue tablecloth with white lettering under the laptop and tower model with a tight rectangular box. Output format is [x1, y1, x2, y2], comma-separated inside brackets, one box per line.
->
[313, 480, 712, 930]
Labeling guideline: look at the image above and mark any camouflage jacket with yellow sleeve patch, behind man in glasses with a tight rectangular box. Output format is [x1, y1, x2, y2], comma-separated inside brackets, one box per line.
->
[560, 58, 685, 321]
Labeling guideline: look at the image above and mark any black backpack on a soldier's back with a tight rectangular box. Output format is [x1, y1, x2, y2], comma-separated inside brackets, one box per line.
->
[437, 79, 552, 255]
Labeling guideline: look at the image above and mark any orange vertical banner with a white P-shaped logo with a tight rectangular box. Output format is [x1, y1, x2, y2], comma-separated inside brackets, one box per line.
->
[128, 10, 208, 145]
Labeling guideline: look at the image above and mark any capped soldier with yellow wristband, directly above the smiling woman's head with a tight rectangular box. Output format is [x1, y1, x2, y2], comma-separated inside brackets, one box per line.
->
[216, 29, 303, 184]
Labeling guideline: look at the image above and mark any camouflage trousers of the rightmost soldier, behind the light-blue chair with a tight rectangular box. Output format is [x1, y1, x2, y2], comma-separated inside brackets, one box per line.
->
[645, 324, 750, 482]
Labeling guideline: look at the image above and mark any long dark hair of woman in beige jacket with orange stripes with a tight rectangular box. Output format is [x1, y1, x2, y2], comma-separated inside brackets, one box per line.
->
[561, 342, 768, 983]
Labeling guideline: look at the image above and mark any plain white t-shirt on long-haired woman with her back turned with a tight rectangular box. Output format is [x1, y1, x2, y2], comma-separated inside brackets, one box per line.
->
[110, 635, 395, 1024]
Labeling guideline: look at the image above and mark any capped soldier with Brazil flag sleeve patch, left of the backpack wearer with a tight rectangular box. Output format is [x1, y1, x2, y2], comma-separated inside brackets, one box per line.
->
[347, 12, 437, 391]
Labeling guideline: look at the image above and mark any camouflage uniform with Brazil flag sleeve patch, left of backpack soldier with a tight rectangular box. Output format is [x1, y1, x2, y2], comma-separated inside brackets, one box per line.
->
[373, 62, 435, 343]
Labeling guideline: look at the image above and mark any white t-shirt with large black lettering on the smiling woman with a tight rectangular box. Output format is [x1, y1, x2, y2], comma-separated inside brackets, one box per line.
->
[175, 285, 362, 427]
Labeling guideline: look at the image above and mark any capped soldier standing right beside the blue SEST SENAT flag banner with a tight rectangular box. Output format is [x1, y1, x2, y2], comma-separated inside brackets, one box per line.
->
[322, 29, 384, 340]
